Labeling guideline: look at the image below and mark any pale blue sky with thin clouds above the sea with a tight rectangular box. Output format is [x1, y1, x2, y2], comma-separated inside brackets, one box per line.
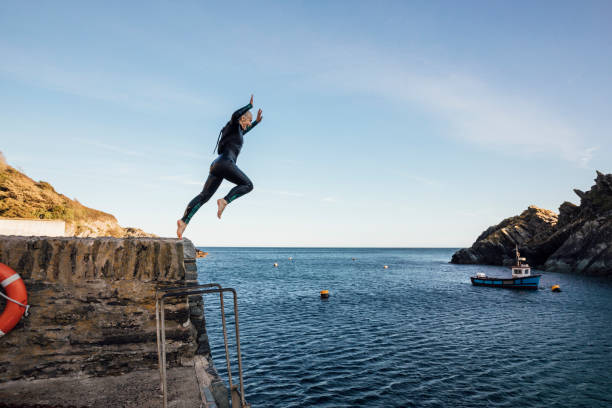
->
[0, 1, 612, 247]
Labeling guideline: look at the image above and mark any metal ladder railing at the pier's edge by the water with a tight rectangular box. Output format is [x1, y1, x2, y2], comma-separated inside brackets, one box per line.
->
[155, 283, 251, 408]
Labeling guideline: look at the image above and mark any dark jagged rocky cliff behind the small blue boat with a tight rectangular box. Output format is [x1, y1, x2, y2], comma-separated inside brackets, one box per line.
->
[451, 171, 612, 276]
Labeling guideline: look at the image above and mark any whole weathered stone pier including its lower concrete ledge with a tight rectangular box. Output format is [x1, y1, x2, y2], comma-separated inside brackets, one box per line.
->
[0, 236, 228, 407]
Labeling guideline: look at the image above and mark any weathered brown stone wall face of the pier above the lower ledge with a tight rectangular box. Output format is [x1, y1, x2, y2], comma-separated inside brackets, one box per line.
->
[0, 236, 202, 382]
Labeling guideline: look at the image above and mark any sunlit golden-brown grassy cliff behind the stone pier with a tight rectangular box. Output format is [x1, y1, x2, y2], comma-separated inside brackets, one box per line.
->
[0, 157, 154, 238]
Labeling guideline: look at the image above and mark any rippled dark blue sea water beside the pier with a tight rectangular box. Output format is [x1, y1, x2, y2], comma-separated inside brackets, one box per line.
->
[198, 248, 612, 408]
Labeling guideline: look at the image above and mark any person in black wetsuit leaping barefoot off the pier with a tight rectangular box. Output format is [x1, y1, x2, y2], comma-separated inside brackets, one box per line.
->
[176, 95, 263, 239]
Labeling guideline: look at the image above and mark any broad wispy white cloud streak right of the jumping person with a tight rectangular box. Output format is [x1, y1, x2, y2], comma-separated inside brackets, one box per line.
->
[330, 59, 595, 166]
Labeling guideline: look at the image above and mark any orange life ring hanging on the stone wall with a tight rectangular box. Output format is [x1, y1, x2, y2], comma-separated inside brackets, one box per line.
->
[0, 263, 29, 337]
